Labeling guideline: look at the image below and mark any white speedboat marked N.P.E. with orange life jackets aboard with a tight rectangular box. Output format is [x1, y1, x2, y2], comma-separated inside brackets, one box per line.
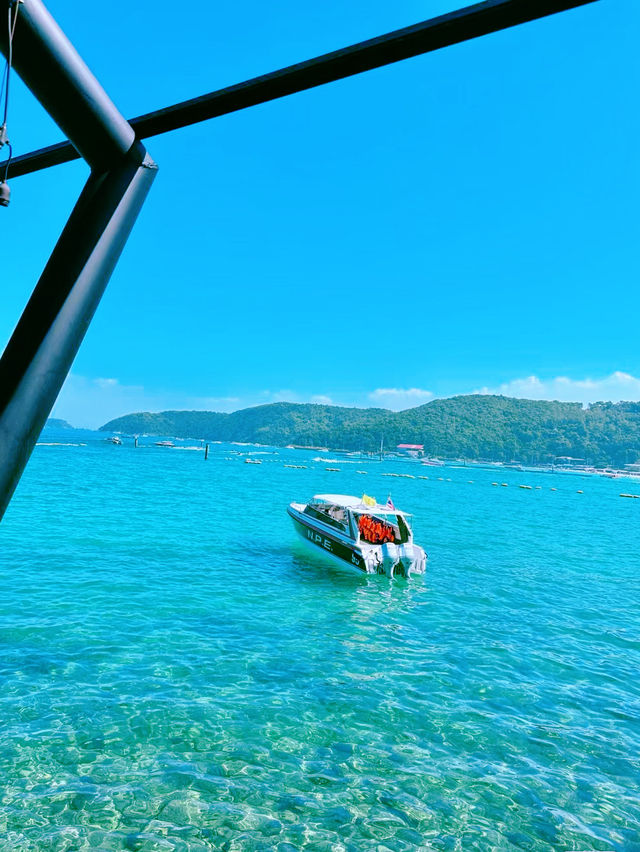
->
[287, 494, 427, 577]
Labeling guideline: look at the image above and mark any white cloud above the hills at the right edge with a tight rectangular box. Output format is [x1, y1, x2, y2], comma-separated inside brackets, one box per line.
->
[473, 370, 640, 405]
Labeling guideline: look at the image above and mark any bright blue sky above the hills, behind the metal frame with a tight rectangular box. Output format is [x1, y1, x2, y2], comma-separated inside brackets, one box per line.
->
[0, 0, 640, 425]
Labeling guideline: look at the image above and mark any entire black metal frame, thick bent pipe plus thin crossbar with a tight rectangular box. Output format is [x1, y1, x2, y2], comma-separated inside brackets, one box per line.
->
[0, 0, 597, 518]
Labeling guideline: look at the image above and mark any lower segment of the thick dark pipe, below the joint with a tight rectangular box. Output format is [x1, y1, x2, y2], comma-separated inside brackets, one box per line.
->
[0, 151, 157, 518]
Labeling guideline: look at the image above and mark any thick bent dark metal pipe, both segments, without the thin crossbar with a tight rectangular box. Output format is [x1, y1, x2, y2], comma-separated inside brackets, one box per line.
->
[0, 0, 157, 518]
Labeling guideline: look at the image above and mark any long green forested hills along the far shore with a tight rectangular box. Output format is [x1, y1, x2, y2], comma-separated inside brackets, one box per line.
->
[100, 394, 640, 467]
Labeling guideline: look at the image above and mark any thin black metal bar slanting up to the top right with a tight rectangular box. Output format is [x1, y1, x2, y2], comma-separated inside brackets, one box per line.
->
[9, 0, 597, 177]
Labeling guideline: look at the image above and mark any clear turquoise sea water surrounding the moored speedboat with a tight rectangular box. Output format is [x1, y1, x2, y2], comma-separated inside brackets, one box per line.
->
[0, 433, 640, 852]
